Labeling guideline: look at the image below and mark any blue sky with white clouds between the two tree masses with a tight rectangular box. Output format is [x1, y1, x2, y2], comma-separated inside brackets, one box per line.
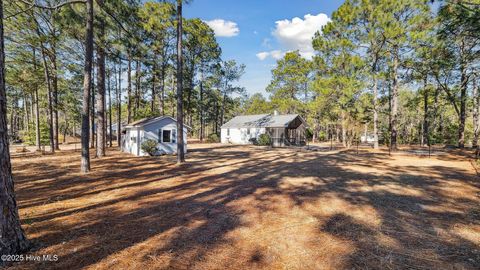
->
[184, 0, 343, 96]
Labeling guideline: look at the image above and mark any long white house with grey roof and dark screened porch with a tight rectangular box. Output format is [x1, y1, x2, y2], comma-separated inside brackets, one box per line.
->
[221, 113, 306, 146]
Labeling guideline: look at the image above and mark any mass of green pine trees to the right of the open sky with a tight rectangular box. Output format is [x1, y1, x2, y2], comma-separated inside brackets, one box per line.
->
[245, 0, 480, 149]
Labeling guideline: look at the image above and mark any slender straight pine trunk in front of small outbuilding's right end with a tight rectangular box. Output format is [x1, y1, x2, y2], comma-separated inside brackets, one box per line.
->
[177, 0, 185, 163]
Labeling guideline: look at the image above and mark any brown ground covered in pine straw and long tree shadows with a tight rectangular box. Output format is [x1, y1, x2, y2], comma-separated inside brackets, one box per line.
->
[5, 144, 480, 269]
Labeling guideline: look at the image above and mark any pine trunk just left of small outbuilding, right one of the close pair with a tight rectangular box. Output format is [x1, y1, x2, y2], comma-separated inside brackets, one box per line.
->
[96, 11, 106, 158]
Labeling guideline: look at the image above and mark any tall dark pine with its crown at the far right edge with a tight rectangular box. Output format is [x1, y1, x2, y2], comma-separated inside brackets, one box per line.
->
[435, 1, 480, 147]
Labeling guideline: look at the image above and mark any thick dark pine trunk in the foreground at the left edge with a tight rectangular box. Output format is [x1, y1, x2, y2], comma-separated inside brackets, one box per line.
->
[0, 0, 29, 255]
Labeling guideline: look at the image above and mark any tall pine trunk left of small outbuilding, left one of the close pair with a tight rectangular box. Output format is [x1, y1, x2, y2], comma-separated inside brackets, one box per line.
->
[80, 0, 93, 173]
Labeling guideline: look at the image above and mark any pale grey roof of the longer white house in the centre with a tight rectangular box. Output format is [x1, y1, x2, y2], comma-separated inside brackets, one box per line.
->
[222, 114, 305, 128]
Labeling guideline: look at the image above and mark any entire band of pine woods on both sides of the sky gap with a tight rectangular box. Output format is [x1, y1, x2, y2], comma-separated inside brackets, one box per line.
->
[0, 0, 480, 265]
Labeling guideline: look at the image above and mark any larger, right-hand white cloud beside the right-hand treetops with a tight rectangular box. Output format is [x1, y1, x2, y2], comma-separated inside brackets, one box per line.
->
[272, 13, 330, 58]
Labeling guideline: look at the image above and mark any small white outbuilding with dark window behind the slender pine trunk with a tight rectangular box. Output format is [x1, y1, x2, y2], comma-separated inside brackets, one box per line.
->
[122, 116, 189, 156]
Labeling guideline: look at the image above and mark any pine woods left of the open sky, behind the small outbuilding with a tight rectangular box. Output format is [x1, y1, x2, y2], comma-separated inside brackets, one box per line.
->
[5, 0, 245, 165]
